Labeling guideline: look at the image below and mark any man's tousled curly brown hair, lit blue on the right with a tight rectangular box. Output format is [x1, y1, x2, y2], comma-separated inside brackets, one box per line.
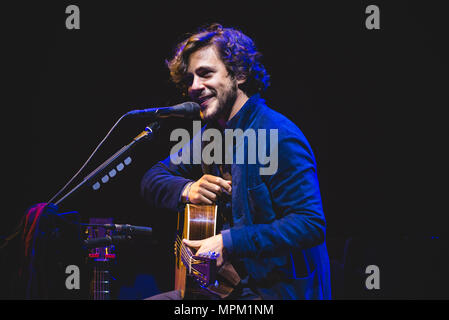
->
[166, 23, 270, 96]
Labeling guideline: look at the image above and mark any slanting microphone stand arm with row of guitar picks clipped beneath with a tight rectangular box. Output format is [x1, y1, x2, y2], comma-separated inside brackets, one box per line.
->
[55, 122, 160, 205]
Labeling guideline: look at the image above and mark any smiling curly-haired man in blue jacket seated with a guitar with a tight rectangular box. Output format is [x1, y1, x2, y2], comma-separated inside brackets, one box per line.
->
[142, 24, 330, 299]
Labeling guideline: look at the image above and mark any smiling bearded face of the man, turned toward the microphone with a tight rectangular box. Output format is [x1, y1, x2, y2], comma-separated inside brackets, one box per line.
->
[187, 45, 248, 121]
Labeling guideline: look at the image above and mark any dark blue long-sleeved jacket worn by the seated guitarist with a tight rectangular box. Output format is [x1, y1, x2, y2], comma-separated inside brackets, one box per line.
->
[141, 94, 331, 299]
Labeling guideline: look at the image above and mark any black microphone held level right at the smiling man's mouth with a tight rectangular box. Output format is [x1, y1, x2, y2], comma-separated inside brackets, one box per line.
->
[125, 102, 200, 120]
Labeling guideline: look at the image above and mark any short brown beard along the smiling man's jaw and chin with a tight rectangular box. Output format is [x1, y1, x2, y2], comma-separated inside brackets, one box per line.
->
[203, 79, 238, 121]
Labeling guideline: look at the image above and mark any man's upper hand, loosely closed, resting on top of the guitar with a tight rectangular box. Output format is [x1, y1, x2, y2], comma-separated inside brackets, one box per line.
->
[182, 174, 232, 204]
